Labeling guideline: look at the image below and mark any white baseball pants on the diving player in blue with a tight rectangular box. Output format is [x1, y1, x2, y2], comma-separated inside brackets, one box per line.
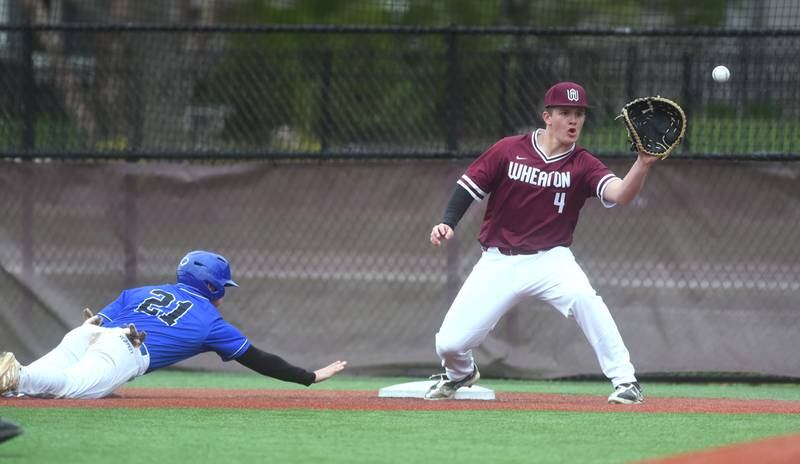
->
[17, 324, 150, 399]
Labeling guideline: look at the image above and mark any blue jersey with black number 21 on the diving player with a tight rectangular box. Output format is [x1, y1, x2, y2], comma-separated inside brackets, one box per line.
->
[99, 284, 250, 372]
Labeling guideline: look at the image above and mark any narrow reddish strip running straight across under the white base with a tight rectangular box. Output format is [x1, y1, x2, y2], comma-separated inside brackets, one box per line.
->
[0, 388, 800, 414]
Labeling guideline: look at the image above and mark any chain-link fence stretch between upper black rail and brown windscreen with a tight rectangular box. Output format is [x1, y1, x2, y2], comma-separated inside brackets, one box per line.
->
[0, 26, 800, 158]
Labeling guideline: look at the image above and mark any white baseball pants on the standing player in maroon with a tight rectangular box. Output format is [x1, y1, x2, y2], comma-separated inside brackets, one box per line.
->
[436, 247, 636, 387]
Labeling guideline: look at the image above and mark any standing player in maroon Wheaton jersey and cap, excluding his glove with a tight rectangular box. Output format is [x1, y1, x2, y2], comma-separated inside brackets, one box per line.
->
[425, 82, 657, 404]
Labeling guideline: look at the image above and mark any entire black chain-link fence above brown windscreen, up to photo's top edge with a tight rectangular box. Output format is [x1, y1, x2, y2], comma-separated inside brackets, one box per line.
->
[0, 0, 800, 159]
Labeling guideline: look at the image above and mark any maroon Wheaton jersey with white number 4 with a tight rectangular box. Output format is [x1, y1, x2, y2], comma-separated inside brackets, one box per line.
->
[458, 132, 617, 252]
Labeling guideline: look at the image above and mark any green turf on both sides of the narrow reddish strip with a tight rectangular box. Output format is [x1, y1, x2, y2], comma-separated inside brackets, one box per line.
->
[0, 371, 800, 464]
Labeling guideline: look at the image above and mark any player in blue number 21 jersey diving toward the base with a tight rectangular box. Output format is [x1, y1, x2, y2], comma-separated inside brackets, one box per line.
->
[0, 251, 347, 398]
